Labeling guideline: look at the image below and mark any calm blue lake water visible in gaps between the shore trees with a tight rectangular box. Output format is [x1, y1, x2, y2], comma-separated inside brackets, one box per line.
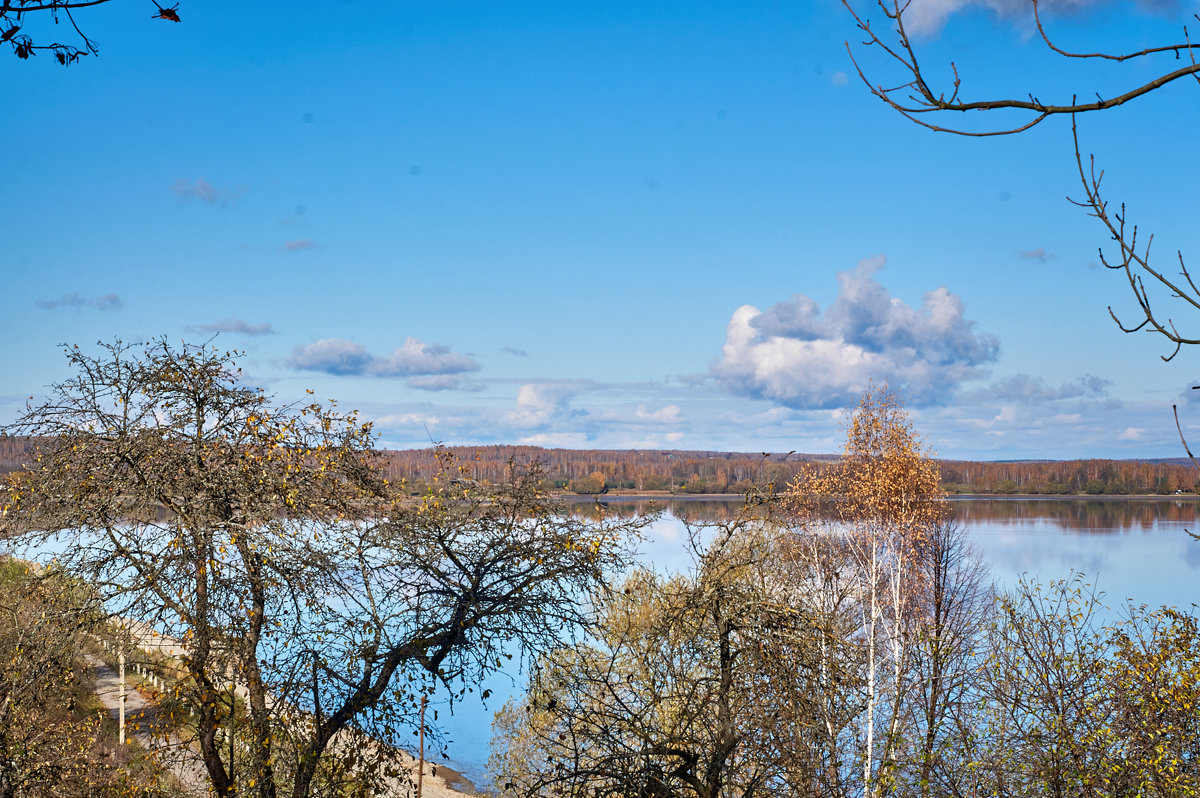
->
[440, 497, 1200, 786]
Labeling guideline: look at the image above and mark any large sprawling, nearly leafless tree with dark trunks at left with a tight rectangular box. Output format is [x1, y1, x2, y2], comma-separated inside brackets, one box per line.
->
[4, 341, 637, 798]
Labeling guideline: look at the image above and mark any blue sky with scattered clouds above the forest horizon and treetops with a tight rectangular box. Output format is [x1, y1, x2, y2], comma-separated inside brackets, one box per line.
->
[0, 0, 1200, 458]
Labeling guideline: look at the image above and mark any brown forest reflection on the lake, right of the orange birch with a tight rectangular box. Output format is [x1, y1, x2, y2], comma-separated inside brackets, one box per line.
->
[950, 497, 1198, 533]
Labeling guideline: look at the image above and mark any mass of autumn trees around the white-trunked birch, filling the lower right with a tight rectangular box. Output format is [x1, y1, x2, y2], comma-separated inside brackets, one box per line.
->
[492, 389, 1200, 798]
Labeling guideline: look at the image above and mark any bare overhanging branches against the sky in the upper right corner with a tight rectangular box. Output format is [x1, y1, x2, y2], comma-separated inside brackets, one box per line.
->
[842, 0, 1200, 360]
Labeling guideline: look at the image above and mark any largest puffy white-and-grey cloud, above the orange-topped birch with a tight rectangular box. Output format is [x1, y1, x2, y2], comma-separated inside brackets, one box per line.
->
[709, 257, 1000, 409]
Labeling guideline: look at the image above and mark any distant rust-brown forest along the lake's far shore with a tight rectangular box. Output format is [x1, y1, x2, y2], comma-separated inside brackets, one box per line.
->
[0, 437, 1200, 496]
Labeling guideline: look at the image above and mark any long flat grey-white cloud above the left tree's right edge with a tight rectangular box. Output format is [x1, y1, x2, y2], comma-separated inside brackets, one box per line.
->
[287, 338, 479, 390]
